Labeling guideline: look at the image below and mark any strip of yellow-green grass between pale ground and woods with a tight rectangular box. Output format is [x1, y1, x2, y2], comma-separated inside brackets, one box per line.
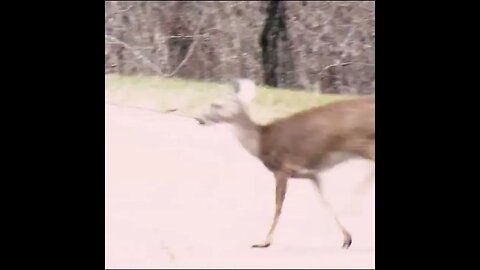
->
[105, 75, 356, 123]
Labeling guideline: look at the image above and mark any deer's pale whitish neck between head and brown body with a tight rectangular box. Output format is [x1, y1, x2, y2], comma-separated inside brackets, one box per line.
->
[232, 110, 260, 157]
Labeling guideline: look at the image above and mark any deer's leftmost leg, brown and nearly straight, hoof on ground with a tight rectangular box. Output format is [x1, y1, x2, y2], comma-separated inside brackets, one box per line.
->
[252, 172, 288, 248]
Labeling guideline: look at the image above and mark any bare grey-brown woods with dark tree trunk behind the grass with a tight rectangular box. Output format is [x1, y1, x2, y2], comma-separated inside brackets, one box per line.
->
[105, 1, 375, 95]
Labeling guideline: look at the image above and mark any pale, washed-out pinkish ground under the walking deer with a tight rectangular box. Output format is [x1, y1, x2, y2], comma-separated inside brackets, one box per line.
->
[105, 104, 375, 268]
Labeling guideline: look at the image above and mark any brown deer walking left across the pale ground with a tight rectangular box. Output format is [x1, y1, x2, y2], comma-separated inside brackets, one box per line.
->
[195, 79, 375, 249]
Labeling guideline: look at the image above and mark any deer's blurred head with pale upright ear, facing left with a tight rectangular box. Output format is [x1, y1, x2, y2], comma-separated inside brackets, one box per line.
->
[196, 79, 256, 125]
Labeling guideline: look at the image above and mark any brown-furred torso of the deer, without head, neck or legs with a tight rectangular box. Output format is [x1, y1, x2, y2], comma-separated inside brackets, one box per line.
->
[258, 97, 375, 177]
